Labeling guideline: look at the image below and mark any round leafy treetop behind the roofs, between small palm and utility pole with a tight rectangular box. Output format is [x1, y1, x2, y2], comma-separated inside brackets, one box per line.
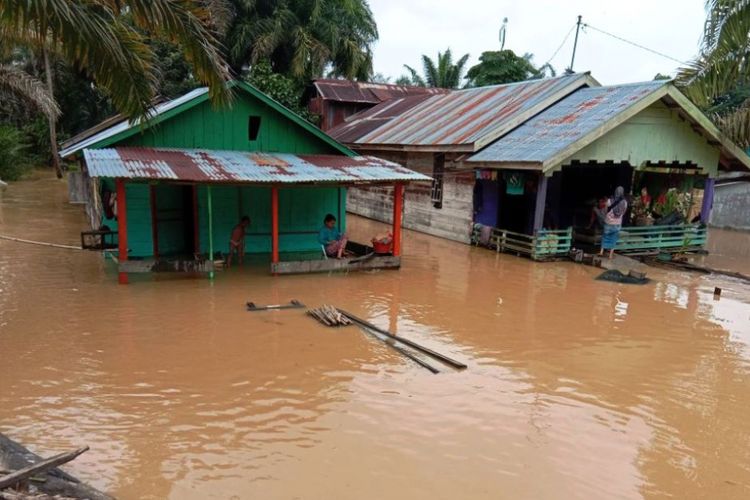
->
[466, 50, 554, 87]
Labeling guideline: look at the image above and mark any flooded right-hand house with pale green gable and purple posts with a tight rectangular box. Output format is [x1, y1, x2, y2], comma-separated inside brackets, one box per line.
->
[330, 74, 750, 258]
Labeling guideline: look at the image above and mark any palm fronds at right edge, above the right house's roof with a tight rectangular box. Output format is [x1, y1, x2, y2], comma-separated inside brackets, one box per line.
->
[676, 0, 750, 147]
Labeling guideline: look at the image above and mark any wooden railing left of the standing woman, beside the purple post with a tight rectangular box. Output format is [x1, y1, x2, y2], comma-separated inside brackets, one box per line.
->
[490, 228, 573, 260]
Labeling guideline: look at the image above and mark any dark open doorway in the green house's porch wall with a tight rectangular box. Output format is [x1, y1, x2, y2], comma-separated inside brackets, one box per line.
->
[151, 185, 195, 257]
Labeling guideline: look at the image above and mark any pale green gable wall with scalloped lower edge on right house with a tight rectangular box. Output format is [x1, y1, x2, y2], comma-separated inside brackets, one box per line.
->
[563, 102, 719, 177]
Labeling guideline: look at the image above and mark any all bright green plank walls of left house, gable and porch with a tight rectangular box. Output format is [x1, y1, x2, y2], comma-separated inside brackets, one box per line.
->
[102, 85, 346, 257]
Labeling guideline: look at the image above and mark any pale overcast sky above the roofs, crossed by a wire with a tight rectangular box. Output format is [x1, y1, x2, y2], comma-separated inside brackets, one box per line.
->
[370, 0, 705, 85]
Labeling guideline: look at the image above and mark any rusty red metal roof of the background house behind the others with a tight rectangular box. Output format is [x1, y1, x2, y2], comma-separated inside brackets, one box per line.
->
[313, 78, 449, 104]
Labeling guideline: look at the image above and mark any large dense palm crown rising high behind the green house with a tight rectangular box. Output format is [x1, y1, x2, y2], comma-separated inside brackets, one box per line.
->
[225, 0, 378, 80]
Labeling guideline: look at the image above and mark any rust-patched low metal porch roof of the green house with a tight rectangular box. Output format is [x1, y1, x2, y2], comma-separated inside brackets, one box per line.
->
[83, 147, 430, 184]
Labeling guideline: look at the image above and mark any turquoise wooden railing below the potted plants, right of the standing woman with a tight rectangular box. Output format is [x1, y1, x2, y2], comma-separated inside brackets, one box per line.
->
[615, 224, 708, 253]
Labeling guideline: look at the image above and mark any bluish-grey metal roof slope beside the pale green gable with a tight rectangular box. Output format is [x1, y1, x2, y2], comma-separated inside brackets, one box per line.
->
[467, 81, 668, 163]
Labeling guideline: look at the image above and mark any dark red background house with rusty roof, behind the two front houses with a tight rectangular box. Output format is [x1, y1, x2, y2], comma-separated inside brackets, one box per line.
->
[304, 78, 449, 131]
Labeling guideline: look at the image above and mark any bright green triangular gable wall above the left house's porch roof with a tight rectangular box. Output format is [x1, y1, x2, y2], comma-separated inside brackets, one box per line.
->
[116, 92, 341, 154]
